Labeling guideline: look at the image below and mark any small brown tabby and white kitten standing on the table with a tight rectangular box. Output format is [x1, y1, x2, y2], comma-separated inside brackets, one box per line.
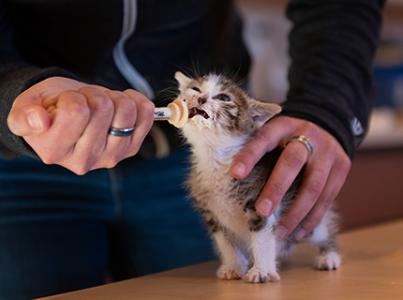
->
[175, 72, 340, 283]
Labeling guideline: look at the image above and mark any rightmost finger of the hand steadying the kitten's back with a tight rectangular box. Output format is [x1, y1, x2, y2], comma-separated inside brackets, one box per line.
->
[295, 157, 349, 240]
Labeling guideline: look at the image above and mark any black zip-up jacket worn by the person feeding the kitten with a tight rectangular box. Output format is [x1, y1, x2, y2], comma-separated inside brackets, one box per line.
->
[0, 0, 383, 158]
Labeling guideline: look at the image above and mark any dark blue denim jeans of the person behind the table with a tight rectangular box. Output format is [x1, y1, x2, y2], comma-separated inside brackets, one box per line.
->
[0, 149, 214, 299]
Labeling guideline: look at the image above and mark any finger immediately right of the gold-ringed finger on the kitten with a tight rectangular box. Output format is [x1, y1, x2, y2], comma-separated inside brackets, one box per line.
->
[276, 155, 333, 239]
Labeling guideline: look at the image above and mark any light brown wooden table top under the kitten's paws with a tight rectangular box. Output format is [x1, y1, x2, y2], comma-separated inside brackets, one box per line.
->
[43, 220, 403, 300]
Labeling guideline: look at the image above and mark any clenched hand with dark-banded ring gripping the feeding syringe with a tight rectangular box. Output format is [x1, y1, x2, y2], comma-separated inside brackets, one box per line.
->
[7, 77, 154, 175]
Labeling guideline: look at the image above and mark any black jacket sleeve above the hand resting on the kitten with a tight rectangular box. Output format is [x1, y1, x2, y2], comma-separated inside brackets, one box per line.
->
[283, 0, 384, 158]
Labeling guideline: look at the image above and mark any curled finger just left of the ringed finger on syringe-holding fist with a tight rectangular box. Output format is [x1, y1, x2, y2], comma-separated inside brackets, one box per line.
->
[72, 87, 114, 173]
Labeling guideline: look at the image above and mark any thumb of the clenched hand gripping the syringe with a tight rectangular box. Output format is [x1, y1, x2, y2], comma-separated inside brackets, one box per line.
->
[7, 104, 50, 136]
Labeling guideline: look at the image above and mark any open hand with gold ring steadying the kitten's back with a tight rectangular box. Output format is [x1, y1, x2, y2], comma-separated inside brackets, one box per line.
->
[231, 116, 351, 240]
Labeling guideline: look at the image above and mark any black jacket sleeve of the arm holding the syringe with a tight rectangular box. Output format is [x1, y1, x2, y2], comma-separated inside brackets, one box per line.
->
[0, 0, 74, 158]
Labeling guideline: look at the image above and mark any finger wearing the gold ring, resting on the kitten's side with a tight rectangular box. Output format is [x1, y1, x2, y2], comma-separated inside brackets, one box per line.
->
[256, 142, 308, 216]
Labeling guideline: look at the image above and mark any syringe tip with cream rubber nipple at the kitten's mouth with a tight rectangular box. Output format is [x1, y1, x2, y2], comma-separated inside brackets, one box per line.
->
[154, 98, 189, 128]
